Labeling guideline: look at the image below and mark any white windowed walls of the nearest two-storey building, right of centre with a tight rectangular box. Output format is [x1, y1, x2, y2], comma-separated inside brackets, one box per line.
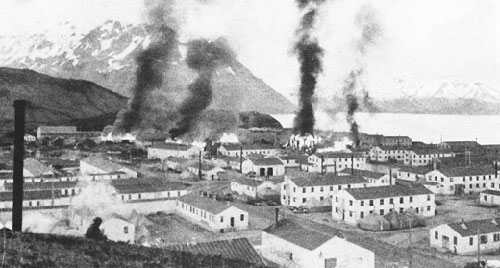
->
[332, 190, 436, 225]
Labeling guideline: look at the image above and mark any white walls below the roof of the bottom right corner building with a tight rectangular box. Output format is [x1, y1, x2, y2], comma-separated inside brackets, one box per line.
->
[429, 224, 500, 255]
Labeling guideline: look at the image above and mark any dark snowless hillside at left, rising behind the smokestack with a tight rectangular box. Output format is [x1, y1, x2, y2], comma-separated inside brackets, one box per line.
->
[0, 67, 127, 132]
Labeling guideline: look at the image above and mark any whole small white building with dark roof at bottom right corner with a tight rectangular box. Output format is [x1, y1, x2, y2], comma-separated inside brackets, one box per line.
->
[429, 218, 500, 255]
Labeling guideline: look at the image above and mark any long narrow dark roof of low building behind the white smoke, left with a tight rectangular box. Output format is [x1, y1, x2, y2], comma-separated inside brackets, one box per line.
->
[111, 179, 187, 194]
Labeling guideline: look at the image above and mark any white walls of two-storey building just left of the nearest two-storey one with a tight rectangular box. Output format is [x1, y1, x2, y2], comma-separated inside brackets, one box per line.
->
[281, 178, 366, 207]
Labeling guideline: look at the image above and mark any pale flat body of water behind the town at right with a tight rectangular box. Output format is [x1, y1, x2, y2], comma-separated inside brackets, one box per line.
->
[272, 112, 500, 144]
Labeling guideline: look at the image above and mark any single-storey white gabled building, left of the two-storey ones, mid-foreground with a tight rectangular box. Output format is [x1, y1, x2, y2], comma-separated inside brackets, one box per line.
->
[175, 194, 248, 232]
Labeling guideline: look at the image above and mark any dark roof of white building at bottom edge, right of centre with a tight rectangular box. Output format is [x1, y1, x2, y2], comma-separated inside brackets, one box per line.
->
[264, 219, 342, 251]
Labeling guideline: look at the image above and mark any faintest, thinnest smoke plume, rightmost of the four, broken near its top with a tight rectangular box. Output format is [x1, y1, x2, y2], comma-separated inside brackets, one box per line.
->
[342, 5, 382, 147]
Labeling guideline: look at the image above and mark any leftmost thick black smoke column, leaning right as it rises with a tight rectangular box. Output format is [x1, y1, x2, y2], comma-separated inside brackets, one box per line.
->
[113, 3, 176, 133]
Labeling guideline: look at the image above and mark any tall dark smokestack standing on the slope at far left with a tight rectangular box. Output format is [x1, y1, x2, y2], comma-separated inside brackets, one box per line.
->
[12, 100, 26, 232]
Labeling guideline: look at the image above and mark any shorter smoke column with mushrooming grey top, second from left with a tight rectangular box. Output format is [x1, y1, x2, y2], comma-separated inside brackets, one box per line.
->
[170, 39, 234, 139]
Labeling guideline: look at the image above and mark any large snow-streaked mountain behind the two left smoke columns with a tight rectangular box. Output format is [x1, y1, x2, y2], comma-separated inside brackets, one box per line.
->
[0, 21, 295, 113]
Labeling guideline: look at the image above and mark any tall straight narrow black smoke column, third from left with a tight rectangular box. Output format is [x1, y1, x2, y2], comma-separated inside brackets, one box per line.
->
[294, 0, 324, 135]
